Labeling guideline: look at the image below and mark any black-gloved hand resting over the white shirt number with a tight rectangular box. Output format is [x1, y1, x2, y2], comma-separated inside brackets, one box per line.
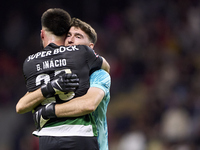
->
[41, 73, 79, 98]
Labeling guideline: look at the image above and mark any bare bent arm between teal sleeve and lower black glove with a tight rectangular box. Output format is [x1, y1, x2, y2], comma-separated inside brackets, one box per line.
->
[55, 87, 104, 117]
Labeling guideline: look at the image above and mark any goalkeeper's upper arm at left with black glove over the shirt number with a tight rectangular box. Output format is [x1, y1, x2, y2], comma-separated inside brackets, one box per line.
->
[16, 74, 79, 114]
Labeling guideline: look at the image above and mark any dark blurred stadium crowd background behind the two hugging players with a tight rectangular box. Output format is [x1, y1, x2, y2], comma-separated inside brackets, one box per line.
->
[0, 0, 200, 150]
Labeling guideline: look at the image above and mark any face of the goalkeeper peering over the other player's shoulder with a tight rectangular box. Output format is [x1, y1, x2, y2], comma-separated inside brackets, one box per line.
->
[65, 27, 93, 48]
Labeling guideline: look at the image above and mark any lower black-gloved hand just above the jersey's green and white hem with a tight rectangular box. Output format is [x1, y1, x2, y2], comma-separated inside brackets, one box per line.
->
[32, 103, 56, 130]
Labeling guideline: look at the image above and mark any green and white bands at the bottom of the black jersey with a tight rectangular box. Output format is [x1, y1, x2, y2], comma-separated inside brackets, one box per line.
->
[33, 114, 97, 136]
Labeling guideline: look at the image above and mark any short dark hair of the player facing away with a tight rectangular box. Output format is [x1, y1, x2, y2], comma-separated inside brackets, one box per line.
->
[41, 8, 71, 36]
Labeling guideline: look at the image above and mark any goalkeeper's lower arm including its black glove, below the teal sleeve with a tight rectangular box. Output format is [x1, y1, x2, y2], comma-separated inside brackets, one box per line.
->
[33, 87, 104, 129]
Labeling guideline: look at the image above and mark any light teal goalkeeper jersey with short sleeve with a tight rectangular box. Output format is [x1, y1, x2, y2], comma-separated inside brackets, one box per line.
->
[90, 69, 111, 150]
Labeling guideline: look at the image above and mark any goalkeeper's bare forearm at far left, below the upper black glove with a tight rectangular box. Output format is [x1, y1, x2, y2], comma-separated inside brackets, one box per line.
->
[16, 89, 45, 114]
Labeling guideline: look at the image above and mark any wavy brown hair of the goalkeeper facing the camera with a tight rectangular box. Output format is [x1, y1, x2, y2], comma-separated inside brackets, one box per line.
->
[71, 18, 97, 44]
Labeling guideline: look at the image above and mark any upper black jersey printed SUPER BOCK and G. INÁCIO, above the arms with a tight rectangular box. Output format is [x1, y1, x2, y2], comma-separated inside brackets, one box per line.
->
[23, 43, 102, 102]
